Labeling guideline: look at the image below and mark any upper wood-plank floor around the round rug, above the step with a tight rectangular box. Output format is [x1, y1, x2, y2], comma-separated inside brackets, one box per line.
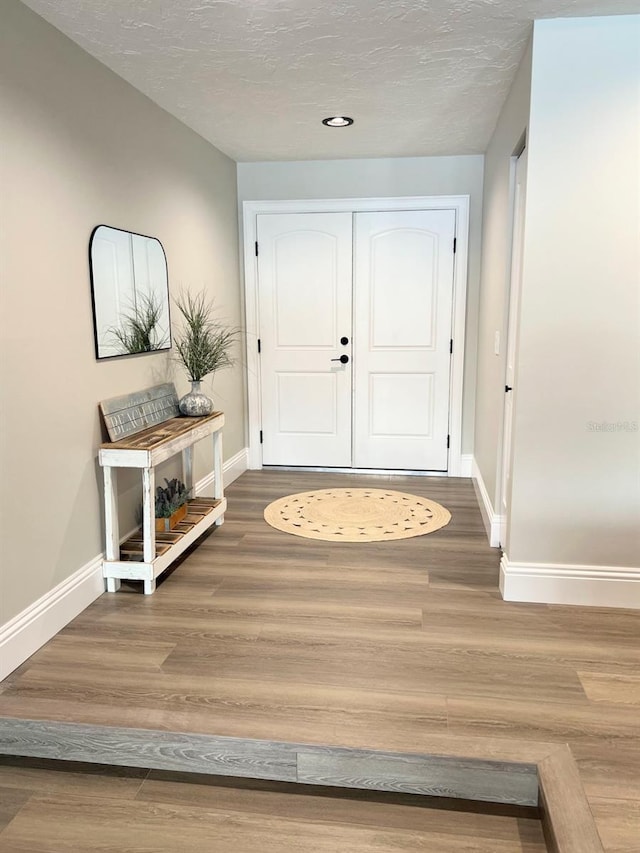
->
[0, 471, 640, 853]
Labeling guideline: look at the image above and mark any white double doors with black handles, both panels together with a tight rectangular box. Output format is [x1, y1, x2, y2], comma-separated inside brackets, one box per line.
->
[257, 210, 455, 471]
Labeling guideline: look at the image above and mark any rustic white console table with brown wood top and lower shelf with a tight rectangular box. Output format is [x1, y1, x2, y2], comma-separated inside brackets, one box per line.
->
[98, 412, 227, 595]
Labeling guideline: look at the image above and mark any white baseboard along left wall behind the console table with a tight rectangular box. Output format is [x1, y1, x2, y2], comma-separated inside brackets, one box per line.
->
[0, 448, 248, 681]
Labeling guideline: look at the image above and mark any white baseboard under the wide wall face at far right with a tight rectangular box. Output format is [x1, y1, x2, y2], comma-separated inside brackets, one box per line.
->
[500, 555, 640, 609]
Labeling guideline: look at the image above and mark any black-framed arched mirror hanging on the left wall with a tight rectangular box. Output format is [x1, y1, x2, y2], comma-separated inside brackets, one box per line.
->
[89, 225, 171, 358]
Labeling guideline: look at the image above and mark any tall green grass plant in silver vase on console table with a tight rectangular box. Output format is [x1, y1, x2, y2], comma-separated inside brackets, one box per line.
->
[174, 293, 238, 417]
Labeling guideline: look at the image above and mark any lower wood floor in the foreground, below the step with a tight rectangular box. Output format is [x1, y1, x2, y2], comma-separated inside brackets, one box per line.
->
[0, 760, 547, 853]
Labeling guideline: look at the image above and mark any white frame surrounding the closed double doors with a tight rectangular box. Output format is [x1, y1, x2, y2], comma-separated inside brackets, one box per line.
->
[242, 195, 469, 477]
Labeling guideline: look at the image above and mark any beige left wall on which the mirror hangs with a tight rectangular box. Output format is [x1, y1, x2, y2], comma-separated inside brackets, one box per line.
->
[0, 0, 244, 624]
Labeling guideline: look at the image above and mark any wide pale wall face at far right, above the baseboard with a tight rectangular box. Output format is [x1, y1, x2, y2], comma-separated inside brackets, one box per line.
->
[508, 15, 640, 564]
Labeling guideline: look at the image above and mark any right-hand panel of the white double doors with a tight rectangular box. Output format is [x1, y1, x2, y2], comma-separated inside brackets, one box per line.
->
[353, 210, 456, 471]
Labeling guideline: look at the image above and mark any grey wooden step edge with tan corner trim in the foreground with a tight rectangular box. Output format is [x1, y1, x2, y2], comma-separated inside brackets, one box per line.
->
[0, 717, 603, 853]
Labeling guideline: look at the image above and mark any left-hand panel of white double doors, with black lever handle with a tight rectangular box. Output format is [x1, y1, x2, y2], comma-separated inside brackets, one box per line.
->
[257, 213, 353, 468]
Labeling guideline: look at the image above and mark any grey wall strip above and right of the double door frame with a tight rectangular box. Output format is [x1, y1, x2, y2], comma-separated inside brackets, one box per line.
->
[238, 155, 483, 453]
